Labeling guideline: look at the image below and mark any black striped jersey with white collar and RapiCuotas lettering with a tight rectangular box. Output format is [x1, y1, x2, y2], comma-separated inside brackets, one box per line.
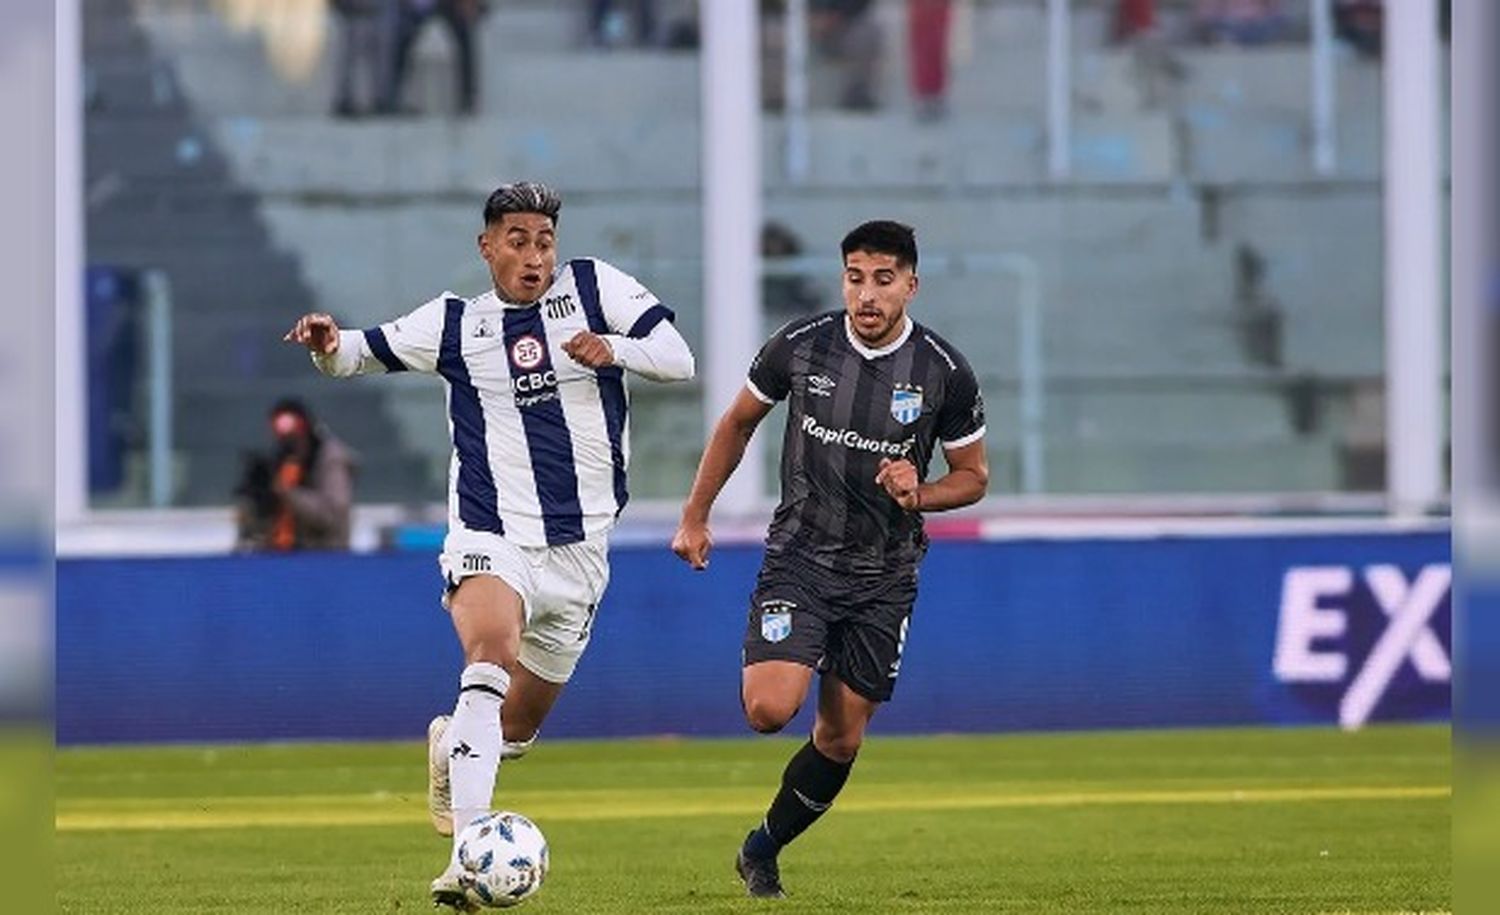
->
[747, 312, 984, 575]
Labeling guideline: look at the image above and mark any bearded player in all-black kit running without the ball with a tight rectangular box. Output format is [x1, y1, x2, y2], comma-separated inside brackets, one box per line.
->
[672, 221, 989, 897]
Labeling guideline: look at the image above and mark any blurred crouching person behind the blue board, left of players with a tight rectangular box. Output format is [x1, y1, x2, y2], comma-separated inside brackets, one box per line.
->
[234, 399, 354, 552]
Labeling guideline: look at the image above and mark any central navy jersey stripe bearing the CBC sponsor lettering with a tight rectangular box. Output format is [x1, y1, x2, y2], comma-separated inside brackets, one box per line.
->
[504, 308, 584, 546]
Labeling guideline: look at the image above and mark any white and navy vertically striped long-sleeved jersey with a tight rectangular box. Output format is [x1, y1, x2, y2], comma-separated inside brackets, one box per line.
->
[314, 258, 693, 546]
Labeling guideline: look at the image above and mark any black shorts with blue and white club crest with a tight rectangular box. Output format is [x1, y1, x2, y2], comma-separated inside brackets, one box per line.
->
[744, 554, 917, 702]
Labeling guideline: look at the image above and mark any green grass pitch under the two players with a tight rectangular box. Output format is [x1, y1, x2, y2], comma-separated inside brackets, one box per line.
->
[56, 726, 1452, 915]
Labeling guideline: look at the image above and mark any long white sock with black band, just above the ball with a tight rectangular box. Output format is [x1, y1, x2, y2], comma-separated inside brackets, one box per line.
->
[443, 662, 510, 842]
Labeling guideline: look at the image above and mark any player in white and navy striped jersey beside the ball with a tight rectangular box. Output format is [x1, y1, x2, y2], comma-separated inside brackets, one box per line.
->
[287, 183, 693, 911]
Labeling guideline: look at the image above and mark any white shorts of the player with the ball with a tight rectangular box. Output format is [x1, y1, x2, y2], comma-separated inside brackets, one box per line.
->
[438, 531, 609, 683]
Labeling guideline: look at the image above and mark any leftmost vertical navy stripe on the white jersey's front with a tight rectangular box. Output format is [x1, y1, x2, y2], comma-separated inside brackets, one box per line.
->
[438, 299, 506, 534]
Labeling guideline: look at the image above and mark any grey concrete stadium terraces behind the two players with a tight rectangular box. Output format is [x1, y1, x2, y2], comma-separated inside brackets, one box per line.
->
[86, 0, 1416, 504]
